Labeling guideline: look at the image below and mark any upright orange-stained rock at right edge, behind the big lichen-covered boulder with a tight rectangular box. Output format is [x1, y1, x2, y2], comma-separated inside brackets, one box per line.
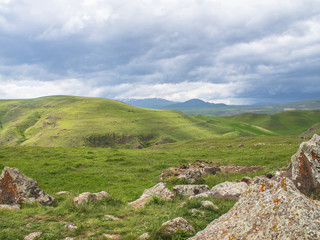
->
[291, 134, 320, 193]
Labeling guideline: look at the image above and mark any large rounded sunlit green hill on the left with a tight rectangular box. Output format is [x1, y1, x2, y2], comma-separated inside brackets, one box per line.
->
[0, 96, 235, 148]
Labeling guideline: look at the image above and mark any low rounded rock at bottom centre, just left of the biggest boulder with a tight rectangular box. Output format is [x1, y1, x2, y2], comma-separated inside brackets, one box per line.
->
[160, 217, 194, 235]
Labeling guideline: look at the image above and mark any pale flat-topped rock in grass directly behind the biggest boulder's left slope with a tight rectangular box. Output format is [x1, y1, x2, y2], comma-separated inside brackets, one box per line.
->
[211, 182, 248, 199]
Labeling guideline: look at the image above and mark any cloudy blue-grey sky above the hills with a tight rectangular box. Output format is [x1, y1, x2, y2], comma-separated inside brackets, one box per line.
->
[0, 0, 320, 104]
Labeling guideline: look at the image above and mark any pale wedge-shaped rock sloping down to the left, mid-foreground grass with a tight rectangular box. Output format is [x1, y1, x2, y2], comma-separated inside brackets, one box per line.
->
[128, 182, 175, 208]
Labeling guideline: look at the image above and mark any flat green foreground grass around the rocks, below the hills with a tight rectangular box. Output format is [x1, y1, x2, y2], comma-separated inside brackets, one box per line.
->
[0, 136, 301, 239]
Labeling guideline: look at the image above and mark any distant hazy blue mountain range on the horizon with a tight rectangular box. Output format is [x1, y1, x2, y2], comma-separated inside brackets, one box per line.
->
[121, 98, 320, 116]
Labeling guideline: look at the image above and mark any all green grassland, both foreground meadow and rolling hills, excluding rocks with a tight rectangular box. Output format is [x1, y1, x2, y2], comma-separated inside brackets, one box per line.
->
[0, 96, 320, 240]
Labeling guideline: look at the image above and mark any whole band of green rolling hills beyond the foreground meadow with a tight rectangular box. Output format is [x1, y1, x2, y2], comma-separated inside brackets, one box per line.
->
[0, 96, 320, 148]
